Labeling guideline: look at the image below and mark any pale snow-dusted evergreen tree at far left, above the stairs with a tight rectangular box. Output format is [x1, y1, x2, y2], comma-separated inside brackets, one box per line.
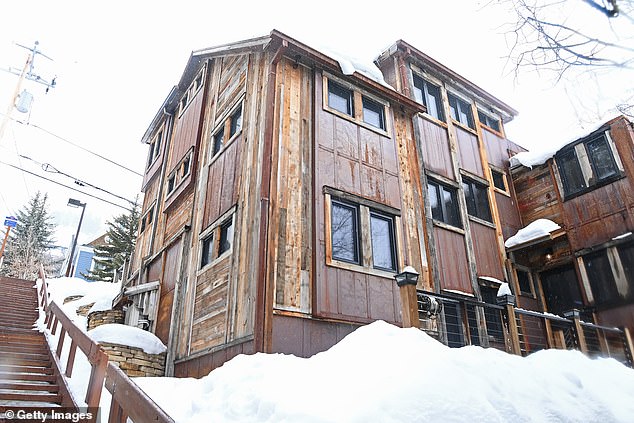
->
[0, 191, 56, 279]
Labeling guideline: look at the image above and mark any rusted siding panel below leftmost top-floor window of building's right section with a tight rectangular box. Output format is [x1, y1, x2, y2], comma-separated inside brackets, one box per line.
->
[417, 116, 455, 179]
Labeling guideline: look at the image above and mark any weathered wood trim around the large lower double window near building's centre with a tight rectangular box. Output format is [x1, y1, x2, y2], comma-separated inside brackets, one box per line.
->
[324, 189, 402, 279]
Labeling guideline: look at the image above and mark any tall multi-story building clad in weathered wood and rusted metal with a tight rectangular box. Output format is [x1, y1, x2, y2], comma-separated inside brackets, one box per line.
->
[120, 31, 628, 376]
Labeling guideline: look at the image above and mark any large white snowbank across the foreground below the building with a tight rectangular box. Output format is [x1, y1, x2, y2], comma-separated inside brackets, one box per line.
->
[134, 322, 634, 423]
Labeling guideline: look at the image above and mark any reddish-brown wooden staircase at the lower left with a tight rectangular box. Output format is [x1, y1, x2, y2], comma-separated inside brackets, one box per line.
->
[0, 277, 75, 412]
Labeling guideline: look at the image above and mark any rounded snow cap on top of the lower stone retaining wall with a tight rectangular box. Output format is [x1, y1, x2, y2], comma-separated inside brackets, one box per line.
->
[88, 323, 167, 354]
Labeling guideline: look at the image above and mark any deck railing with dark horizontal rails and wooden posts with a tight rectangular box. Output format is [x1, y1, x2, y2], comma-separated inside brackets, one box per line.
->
[417, 290, 634, 367]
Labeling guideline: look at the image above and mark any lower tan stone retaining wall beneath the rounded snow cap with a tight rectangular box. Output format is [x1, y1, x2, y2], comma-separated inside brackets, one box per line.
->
[99, 342, 165, 377]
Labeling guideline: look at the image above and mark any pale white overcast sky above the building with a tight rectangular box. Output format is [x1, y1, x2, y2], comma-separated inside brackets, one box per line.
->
[0, 0, 632, 252]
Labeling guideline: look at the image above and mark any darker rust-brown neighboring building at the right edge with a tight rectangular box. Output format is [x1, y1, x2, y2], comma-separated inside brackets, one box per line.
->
[509, 116, 634, 330]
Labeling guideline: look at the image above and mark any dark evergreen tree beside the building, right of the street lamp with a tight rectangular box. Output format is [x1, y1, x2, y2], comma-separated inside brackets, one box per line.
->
[83, 204, 139, 282]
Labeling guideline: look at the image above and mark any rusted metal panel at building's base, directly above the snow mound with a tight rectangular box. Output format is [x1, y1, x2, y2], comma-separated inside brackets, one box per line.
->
[271, 315, 358, 357]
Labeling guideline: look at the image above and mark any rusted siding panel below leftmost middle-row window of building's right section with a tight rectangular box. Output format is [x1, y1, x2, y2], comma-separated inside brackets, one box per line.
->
[434, 226, 473, 292]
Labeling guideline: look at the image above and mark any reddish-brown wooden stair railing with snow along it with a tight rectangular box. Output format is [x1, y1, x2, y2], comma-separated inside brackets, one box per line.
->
[39, 266, 174, 423]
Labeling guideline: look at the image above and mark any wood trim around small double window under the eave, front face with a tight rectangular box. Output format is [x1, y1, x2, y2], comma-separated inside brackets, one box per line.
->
[322, 73, 392, 138]
